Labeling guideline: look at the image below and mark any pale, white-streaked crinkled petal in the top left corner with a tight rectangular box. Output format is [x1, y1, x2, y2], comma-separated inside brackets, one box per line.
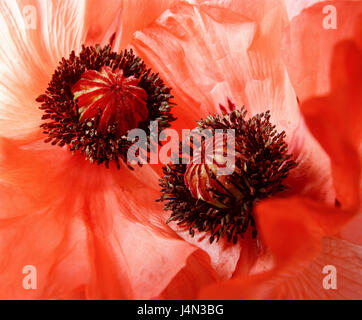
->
[0, 0, 85, 137]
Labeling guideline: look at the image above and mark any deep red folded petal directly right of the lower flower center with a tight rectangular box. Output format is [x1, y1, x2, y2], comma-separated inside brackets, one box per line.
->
[255, 197, 355, 263]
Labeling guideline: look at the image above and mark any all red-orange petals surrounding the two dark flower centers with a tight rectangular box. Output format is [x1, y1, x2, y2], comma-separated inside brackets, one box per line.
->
[0, 0, 362, 299]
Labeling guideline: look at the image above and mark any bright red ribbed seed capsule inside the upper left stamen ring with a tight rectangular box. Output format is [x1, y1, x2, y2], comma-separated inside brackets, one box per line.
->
[71, 66, 149, 136]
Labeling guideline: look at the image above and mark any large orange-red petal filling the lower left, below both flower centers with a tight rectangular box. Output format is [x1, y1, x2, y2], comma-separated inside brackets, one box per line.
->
[0, 137, 201, 299]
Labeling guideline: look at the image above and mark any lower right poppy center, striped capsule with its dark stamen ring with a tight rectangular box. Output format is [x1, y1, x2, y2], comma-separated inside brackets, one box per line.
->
[159, 102, 296, 243]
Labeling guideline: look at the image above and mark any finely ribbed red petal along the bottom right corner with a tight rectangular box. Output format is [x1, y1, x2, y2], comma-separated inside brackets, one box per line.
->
[199, 238, 362, 300]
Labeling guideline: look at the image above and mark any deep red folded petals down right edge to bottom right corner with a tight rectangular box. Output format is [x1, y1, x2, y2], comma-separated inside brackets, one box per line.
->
[201, 36, 362, 299]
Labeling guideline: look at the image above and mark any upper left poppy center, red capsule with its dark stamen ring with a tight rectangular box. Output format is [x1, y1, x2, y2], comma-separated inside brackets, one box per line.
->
[36, 45, 175, 169]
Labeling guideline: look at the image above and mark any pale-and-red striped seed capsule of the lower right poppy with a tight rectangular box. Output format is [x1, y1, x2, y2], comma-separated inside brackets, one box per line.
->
[184, 135, 243, 208]
